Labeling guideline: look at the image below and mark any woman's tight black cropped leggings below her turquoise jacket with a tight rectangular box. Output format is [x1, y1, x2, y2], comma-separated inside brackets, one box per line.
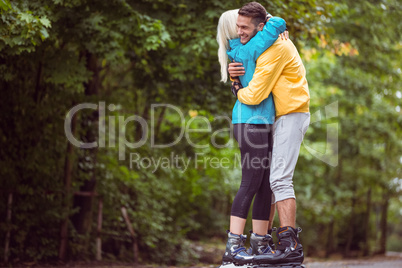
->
[231, 124, 273, 221]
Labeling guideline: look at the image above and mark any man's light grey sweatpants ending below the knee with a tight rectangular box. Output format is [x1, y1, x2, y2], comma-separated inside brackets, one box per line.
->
[270, 113, 310, 203]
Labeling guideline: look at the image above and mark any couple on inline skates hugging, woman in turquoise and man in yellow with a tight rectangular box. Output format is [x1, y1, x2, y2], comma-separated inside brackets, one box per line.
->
[217, 2, 310, 267]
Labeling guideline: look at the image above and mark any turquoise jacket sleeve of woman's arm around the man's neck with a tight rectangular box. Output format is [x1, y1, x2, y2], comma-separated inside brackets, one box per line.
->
[240, 17, 286, 61]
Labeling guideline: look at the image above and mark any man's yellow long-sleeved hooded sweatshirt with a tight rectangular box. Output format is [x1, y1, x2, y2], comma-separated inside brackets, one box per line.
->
[237, 38, 310, 118]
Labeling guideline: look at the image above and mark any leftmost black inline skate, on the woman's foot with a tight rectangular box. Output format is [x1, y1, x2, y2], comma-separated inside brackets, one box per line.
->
[222, 232, 253, 266]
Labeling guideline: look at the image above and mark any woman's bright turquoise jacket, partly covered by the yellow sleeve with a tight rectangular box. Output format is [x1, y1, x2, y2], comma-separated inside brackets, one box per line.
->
[227, 17, 286, 124]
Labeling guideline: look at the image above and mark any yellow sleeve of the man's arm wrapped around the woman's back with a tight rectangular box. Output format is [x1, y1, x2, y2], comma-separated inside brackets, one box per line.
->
[237, 45, 286, 105]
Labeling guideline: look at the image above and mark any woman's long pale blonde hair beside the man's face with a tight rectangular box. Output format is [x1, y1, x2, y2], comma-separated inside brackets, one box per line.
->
[216, 9, 239, 82]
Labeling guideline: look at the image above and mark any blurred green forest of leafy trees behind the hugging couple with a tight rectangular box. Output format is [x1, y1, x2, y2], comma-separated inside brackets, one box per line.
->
[0, 0, 402, 265]
